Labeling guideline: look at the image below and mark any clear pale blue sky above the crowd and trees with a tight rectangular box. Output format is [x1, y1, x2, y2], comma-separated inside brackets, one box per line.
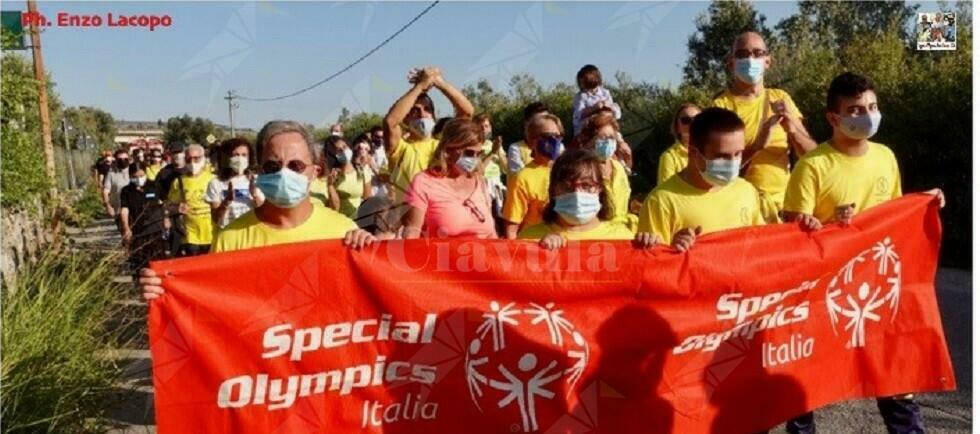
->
[3, 1, 936, 129]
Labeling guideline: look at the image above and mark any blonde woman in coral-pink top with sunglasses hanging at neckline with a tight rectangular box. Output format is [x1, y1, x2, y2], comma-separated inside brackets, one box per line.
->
[402, 119, 497, 239]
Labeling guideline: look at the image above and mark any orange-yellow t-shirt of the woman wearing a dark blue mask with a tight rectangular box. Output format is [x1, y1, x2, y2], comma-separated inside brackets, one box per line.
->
[501, 161, 551, 228]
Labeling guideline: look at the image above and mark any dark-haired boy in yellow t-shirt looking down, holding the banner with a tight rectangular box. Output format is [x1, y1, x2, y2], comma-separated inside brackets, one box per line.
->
[639, 107, 765, 251]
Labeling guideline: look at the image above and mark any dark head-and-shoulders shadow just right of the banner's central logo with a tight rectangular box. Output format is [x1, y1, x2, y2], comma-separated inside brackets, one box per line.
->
[556, 304, 677, 433]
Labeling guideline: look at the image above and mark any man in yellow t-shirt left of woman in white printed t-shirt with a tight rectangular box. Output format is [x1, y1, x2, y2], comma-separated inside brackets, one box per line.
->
[167, 144, 214, 257]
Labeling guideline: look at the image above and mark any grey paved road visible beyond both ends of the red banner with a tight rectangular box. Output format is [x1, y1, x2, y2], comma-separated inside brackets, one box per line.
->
[80, 222, 973, 434]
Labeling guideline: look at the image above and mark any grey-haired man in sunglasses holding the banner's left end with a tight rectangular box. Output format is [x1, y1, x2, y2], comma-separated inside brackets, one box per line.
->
[139, 121, 376, 300]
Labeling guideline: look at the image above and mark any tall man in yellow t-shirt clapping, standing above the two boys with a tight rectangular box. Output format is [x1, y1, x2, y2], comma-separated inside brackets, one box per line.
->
[712, 32, 817, 210]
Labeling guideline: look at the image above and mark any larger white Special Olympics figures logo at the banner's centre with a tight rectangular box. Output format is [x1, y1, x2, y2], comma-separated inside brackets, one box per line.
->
[465, 301, 589, 432]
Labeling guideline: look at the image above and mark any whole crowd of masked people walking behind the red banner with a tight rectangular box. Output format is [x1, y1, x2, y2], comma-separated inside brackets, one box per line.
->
[122, 32, 944, 433]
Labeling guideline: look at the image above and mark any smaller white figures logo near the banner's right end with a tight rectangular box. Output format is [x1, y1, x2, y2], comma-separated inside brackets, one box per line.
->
[826, 237, 902, 348]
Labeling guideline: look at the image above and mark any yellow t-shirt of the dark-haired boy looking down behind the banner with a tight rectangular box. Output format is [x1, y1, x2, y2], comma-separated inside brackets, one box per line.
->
[639, 175, 765, 243]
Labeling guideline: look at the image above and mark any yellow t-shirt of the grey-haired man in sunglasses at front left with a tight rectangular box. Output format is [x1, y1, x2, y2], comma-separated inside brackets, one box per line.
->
[211, 205, 357, 253]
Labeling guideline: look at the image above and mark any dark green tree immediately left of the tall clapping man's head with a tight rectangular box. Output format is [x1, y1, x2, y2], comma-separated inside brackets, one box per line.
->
[684, 0, 771, 89]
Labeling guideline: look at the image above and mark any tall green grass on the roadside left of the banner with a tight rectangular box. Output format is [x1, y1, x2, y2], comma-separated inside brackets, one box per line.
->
[0, 251, 132, 433]
